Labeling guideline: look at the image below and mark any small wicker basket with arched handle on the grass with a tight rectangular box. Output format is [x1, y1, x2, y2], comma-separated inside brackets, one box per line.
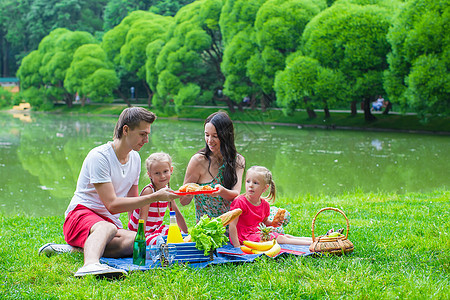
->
[309, 207, 354, 255]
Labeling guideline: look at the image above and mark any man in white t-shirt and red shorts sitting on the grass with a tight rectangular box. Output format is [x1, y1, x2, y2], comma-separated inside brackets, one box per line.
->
[39, 107, 179, 277]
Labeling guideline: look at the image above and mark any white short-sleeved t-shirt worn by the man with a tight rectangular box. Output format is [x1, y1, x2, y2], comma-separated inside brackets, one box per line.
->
[65, 142, 141, 228]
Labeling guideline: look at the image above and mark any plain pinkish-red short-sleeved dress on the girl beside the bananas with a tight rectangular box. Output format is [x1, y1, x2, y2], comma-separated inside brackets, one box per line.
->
[230, 195, 280, 244]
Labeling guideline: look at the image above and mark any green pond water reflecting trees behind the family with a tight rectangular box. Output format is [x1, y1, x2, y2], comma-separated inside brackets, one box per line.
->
[0, 113, 450, 216]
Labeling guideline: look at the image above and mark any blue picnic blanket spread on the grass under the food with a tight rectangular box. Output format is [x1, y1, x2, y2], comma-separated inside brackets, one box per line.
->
[100, 243, 313, 271]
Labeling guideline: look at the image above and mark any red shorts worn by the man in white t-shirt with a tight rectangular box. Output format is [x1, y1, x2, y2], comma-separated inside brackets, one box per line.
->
[63, 204, 114, 248]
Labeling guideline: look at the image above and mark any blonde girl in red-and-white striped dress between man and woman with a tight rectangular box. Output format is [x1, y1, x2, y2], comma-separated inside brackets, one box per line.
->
[128, 152, 188, 245]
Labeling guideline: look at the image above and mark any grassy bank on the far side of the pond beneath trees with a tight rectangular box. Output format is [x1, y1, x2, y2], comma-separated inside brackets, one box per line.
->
[42, 105, 450, 134]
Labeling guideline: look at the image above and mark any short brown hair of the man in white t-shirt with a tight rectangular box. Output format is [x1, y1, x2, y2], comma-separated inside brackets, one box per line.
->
[114, 107, 156, 140]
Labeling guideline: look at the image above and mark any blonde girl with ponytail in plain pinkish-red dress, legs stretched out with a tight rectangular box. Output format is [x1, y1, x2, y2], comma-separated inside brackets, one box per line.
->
[229, 166, 312, 247]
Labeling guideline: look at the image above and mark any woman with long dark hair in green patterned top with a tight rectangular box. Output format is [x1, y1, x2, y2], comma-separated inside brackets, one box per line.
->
[180, 111, 245, 222]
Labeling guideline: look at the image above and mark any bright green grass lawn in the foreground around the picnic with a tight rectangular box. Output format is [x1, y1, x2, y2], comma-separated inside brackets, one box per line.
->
[0, 190, 450, 299]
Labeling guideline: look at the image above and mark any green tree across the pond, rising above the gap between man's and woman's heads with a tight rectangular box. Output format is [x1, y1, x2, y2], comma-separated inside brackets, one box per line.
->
[151, 0, 227, 111]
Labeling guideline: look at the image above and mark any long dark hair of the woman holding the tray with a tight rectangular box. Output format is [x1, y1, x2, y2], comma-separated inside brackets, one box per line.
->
[199, 111, 241, 189]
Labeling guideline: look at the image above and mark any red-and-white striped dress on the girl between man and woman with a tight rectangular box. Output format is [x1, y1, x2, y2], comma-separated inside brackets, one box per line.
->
[128, 184, 169, 245]
